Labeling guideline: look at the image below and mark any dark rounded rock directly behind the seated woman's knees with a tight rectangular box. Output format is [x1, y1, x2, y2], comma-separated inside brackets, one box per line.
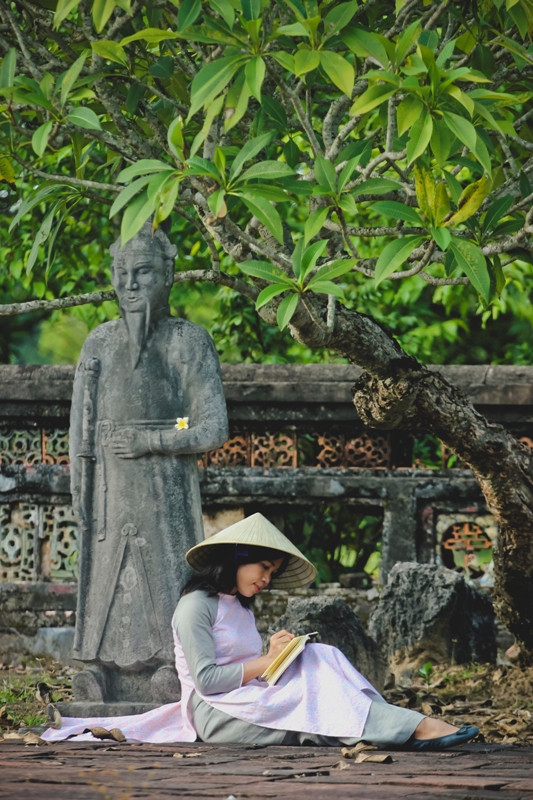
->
[275, 597, 388, 692]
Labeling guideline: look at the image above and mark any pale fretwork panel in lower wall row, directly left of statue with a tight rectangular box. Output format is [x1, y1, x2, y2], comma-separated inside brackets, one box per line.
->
[41, 506, 78, 583]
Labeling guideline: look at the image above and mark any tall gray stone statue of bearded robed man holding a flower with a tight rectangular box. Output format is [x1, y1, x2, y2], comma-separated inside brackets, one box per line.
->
[70, 222, 228, 702]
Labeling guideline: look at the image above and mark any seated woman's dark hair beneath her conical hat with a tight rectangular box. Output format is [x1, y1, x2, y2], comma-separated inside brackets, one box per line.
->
[180, 544, 290, 608]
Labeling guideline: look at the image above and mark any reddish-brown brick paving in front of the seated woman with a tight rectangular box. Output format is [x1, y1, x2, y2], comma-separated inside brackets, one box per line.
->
[0, 741, 533, 800]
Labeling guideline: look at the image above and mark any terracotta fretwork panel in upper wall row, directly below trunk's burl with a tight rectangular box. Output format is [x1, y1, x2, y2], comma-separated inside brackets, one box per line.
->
[316, 433, 390, 469]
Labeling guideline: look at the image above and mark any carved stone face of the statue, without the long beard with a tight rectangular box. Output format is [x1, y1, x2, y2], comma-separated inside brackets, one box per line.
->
[113, 250, 172, 313]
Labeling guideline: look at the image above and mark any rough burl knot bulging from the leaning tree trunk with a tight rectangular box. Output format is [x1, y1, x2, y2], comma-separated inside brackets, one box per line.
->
[352, 369, 424, 430]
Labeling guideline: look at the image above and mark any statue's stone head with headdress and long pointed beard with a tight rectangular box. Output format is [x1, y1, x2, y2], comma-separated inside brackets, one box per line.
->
[109, 220, 177, 369]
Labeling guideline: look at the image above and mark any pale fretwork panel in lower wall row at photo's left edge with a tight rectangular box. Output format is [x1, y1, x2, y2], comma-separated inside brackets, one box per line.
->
[0, 503, 40, 582]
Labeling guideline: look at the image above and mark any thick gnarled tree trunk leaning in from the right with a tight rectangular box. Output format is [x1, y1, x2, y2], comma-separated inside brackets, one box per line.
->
[282, 296, 533, 661]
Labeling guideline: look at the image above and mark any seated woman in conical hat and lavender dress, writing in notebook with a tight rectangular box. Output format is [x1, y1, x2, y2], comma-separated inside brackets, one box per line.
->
[44, 514, 478, 750]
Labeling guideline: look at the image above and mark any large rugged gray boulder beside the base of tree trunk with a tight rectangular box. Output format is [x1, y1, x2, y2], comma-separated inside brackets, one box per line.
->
[368, 562, 497, 680]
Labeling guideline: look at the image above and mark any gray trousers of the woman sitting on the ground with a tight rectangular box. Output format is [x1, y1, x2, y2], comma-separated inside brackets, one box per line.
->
[190, 692, 425, 747]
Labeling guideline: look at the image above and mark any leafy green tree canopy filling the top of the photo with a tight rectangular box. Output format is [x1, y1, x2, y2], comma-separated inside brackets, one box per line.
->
[0, 0, 533, 349]
